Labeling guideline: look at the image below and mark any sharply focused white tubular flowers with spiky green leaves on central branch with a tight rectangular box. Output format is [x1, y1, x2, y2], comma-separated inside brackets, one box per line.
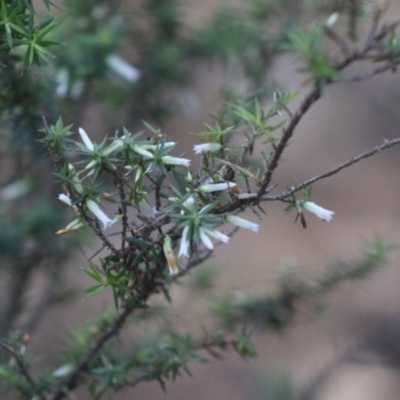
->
[53, 125, 334, 275]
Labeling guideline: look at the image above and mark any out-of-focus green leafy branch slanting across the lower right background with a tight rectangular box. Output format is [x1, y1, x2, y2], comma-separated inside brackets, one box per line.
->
[212, 237, 392, 332]
